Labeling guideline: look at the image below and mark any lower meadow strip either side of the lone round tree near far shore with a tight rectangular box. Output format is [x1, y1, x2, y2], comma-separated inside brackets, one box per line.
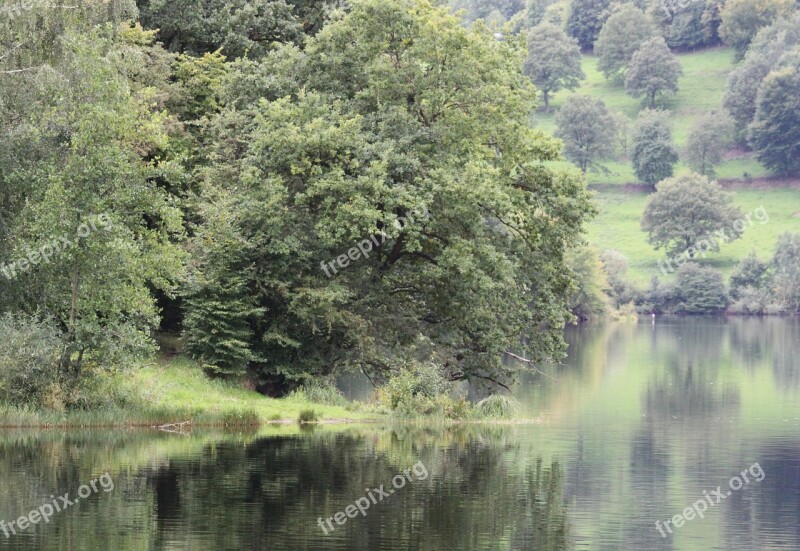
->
[588, 189, 800, 285]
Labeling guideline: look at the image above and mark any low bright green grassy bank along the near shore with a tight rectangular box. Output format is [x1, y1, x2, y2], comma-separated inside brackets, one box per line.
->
[0, 357, 377, 430]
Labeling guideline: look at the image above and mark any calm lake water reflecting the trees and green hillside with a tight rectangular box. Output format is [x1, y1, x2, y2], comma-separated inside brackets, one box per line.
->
[0, 318, 800, 551]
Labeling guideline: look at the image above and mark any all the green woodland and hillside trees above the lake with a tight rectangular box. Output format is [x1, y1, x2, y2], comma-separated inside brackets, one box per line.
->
[0, 0, 800, 416]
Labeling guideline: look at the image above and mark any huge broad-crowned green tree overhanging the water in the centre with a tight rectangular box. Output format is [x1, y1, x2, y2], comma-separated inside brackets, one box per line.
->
[187, 0, 592, 388]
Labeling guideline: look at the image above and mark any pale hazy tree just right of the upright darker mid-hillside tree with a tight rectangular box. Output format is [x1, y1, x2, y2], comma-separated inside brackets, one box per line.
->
[684, 111, 733, 178]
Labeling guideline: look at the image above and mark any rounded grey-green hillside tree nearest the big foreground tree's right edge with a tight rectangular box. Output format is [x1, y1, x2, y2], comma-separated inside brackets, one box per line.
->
[556, 95, 614, 174]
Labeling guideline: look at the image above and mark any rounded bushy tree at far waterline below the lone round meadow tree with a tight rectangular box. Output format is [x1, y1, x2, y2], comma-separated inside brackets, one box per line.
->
[671, 262, 728, 314]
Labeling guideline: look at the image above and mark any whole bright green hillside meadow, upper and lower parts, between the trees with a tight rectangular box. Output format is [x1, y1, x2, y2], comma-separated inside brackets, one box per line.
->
[534, 47, 800, 284]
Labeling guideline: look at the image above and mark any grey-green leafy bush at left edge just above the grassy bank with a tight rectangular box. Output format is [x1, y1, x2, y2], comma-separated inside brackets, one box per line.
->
[0, 314, 63, 409]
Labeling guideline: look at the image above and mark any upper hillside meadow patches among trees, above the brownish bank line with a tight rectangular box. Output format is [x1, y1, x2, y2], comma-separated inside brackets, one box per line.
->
[534, 48, 769, 184]
